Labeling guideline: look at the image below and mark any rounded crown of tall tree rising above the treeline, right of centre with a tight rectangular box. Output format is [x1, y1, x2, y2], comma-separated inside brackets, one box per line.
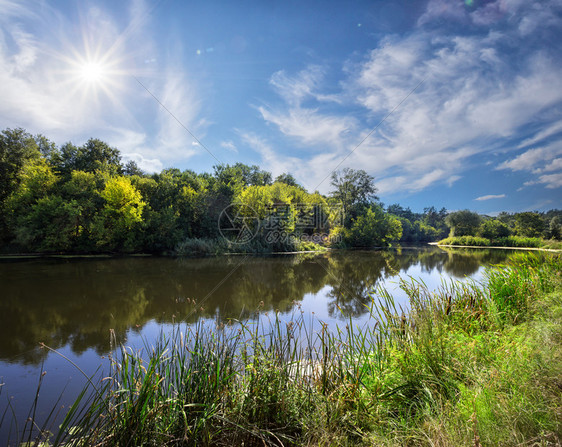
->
[331, 168, 378, 223]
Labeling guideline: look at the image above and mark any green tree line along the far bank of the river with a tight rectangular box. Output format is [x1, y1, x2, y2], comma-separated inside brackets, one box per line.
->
[0, 128, 562, 255]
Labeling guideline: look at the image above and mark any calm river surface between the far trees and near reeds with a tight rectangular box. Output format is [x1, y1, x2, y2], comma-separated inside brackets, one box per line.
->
[0, 247, 512, 445]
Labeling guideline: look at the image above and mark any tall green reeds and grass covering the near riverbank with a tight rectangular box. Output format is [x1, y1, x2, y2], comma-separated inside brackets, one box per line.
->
[5, 254, 562, 446]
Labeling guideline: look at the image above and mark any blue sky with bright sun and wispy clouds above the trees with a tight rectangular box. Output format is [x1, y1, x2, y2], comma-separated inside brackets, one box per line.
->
[0, 0, 562, 214]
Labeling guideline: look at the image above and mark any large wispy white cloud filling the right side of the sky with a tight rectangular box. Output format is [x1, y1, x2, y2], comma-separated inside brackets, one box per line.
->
[254, 0, 562, 193]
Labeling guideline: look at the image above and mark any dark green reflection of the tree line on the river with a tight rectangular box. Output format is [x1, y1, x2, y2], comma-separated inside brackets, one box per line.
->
[0, 247, 510, 364]
